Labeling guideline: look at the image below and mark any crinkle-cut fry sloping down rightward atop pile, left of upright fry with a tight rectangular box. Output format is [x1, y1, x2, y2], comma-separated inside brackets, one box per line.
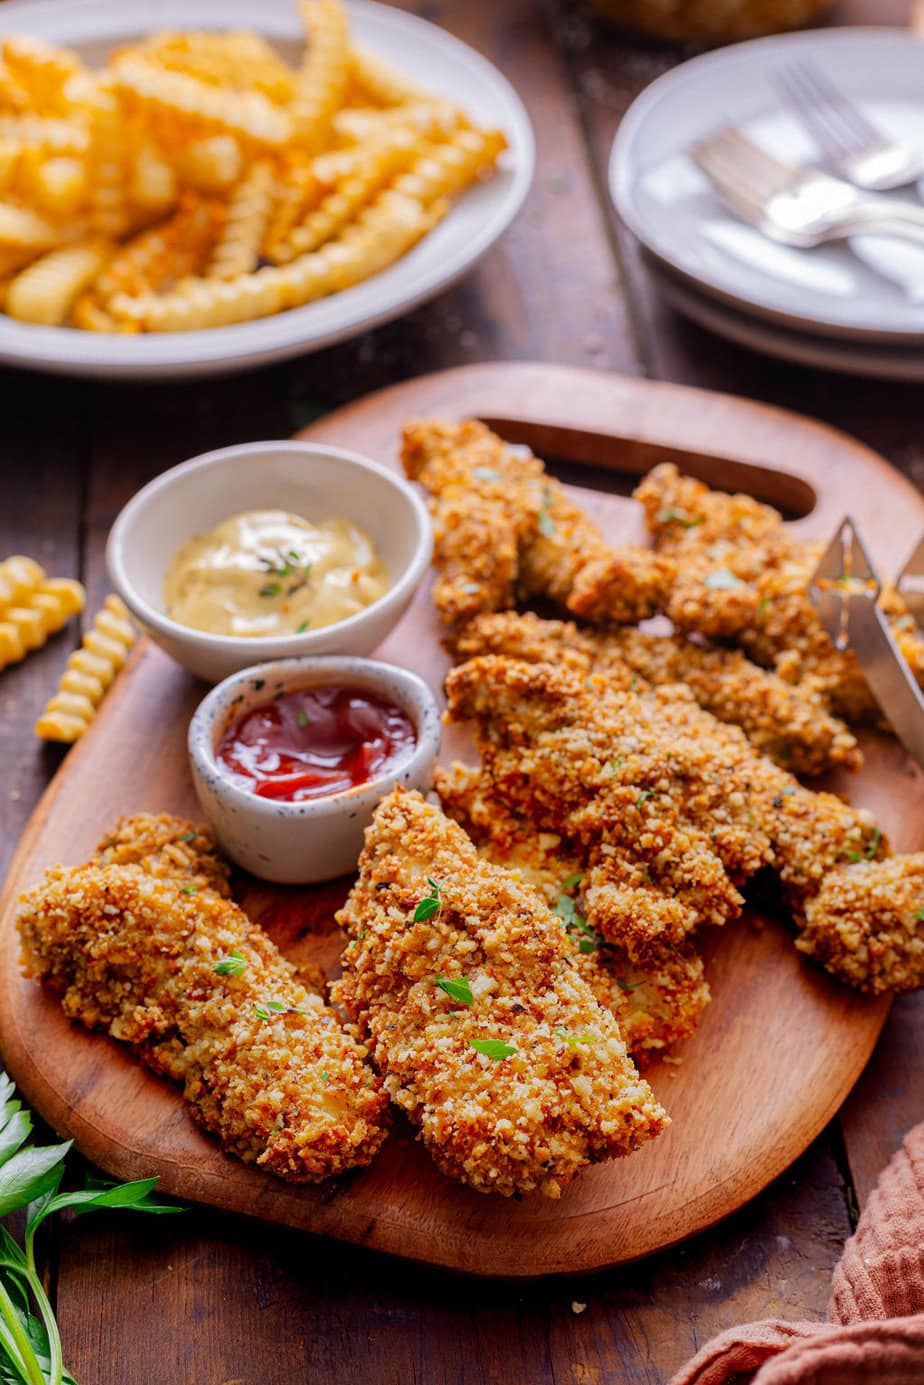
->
[112, 54, 292, 148]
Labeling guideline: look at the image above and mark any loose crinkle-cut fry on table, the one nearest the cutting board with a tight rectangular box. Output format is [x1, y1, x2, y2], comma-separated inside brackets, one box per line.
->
[35, 596, 134, 744]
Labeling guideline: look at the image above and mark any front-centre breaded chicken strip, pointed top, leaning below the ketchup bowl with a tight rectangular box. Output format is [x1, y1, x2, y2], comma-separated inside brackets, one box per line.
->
[334, 789, 666, 1197]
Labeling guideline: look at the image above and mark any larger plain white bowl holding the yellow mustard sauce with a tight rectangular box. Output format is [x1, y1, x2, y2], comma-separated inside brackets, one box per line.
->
[105, 442, 432, 683]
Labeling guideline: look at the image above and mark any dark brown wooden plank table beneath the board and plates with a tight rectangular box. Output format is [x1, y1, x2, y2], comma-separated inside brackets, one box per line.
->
[0, 0, 924, 1385]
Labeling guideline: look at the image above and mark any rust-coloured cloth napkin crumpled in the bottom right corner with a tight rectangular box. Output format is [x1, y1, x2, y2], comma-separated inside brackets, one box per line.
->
[670, 1125, 924, 1385]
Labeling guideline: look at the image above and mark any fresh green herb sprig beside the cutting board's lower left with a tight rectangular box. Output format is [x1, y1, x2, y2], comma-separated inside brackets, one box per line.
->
[0, 1073, 183, 1385]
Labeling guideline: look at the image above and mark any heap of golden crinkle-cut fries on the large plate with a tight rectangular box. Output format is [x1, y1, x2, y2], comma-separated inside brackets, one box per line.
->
[0, 0, 504, 334]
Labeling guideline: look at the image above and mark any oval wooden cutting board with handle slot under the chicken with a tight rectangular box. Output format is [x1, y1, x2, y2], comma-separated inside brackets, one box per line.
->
[0, 364, 924, 1276]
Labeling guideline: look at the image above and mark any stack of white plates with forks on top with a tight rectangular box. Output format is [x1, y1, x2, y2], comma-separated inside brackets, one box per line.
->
[610, 29, 924, 379]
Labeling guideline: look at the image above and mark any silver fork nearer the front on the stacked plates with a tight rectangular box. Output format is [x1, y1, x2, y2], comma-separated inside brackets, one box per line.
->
[690, 126, 924, 247]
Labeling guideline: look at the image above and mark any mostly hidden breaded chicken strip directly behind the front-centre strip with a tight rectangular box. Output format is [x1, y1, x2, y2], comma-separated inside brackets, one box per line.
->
[435, 765, 709, 1062]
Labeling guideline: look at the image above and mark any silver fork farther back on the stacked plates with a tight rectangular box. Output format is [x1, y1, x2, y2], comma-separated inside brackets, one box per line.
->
[777, 61, 924, 193]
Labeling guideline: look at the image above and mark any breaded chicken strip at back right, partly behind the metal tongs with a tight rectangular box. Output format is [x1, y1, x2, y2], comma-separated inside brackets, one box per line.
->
[636, 464, 924, 722]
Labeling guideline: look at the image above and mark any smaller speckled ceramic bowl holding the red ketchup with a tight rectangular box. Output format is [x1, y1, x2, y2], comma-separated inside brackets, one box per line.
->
[188, 658, 442, 885]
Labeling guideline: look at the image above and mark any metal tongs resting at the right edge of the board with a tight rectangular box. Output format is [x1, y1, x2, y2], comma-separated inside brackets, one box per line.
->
[809, 515, 924, 766]
